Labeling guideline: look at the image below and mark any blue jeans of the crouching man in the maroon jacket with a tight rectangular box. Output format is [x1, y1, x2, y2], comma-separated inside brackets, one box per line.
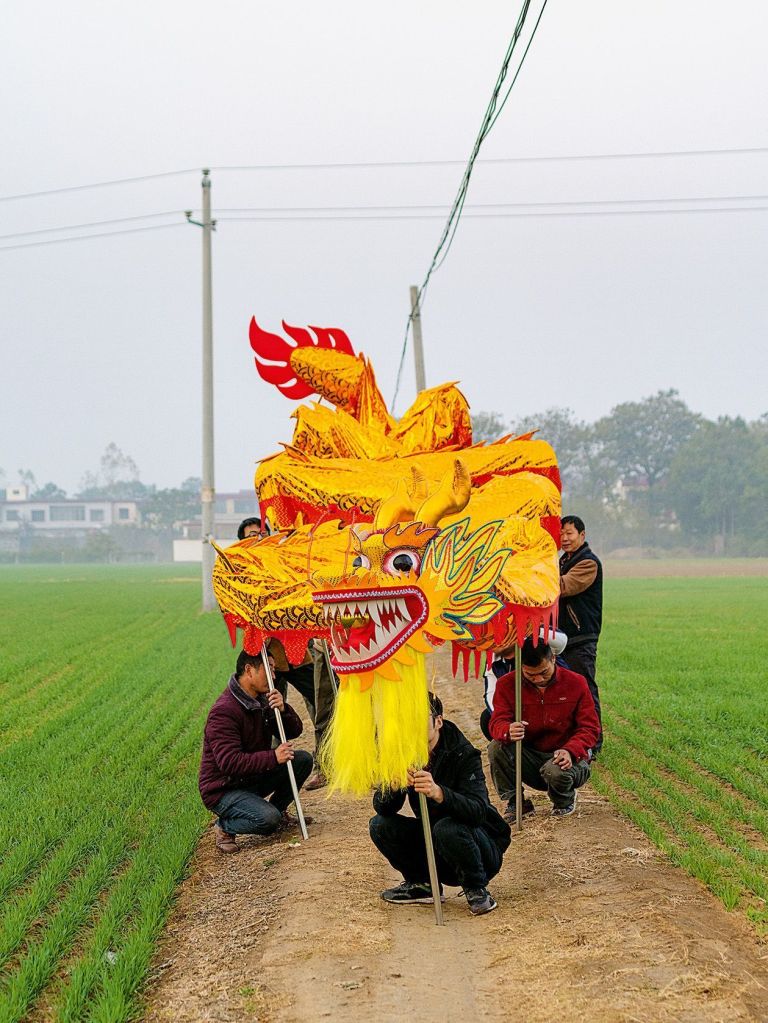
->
[214, 750, 312, 835]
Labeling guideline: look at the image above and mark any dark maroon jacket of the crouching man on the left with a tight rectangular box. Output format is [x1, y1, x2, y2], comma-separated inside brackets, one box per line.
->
[198, 676, 302, 810]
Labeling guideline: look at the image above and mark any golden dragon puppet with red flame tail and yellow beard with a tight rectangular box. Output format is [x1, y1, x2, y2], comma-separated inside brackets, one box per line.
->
[214, 319, 560, 794]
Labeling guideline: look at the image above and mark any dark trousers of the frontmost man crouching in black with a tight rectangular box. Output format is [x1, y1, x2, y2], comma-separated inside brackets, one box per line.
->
[369, 813, 502, 888]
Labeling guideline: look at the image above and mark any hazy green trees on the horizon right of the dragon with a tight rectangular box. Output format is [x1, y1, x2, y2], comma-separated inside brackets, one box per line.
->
[472, 390, 768, 555]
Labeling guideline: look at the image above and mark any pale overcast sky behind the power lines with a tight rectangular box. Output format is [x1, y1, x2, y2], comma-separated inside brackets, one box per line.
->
[0, 0, 768, 492]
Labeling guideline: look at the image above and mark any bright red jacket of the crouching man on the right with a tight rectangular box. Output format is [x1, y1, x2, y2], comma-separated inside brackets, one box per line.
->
[488, 666, 600, 763]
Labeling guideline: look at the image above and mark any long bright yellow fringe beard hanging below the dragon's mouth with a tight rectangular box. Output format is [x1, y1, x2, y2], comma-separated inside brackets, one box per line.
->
[320, 650, 430, 796]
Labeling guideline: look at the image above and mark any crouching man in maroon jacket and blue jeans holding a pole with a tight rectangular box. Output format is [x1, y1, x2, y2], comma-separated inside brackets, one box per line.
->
[198, 651, 312, 852]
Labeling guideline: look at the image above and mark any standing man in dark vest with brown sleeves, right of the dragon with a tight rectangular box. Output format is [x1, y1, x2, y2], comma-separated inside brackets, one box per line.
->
[557, 515, 602, 757]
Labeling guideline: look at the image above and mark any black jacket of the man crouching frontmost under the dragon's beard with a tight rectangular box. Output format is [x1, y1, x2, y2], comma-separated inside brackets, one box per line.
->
[373, 720, 511, 853]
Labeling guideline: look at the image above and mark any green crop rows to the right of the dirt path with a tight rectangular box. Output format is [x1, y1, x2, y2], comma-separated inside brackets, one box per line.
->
[592, 577, 768, 935]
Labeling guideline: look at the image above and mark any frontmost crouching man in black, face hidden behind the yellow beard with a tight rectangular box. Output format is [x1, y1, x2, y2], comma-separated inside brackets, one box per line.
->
[370, 693, 510, 916]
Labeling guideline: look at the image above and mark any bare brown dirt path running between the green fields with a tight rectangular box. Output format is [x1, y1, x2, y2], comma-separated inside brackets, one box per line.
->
[144, 654, 768, 1023]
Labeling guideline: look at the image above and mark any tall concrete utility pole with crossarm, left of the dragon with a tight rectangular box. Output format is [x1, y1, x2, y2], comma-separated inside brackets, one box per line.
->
[186, 169, 216, 611]
